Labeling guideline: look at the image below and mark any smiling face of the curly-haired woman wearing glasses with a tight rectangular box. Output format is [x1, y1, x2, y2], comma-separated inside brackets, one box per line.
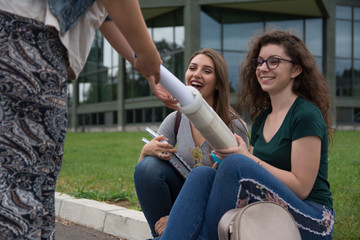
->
[256, 44, 301, 95]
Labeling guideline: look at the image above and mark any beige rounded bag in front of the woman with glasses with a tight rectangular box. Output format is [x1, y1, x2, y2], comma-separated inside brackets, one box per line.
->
[218, 201, 301, 240]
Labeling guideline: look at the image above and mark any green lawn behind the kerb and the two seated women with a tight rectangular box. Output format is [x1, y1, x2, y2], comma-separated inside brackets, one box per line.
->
[56, 131, 360, 240]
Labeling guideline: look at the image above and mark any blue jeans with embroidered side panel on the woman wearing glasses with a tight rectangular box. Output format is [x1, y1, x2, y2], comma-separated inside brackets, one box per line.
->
[160, 154, 334, 240]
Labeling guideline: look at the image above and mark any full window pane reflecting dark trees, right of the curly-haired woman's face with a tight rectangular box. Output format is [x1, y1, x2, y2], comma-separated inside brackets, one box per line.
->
[336, 59, 352, 97]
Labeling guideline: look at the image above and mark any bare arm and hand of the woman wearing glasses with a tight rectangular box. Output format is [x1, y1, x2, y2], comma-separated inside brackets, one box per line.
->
[216, 135, 321, 200]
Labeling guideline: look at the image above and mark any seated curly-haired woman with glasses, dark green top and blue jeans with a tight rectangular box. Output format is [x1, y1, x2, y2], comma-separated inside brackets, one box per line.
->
[161, 31, 334, 240]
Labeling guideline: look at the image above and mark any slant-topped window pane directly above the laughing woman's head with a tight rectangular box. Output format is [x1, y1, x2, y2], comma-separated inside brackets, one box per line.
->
[200, 11, 221, 49]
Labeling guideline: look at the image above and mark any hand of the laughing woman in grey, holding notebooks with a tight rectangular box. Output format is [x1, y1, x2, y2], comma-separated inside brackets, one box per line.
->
[139, 135, 176, 162]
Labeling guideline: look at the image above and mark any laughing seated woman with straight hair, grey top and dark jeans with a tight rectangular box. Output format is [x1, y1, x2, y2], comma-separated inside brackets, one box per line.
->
[134, 48, 249, 237]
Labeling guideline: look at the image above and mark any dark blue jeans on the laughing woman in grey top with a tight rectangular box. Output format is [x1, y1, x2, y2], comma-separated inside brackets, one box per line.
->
[134, 156, 184, 237]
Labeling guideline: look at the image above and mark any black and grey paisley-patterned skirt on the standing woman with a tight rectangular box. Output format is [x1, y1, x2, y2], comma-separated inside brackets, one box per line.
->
[0, 11, 68, 239]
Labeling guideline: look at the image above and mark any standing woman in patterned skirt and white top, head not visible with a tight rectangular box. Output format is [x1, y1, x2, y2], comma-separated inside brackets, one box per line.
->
[0, 0, 176, 240]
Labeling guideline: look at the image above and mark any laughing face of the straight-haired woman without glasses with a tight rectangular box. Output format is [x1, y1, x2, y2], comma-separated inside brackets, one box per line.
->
[185, 54, 217, 106]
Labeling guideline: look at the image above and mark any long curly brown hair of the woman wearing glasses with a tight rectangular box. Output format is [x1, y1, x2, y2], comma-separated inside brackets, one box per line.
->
[237, 30, 332, 139]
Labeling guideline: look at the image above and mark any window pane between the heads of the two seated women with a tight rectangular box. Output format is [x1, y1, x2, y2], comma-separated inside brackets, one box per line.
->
[224, 52, 246, 92]
